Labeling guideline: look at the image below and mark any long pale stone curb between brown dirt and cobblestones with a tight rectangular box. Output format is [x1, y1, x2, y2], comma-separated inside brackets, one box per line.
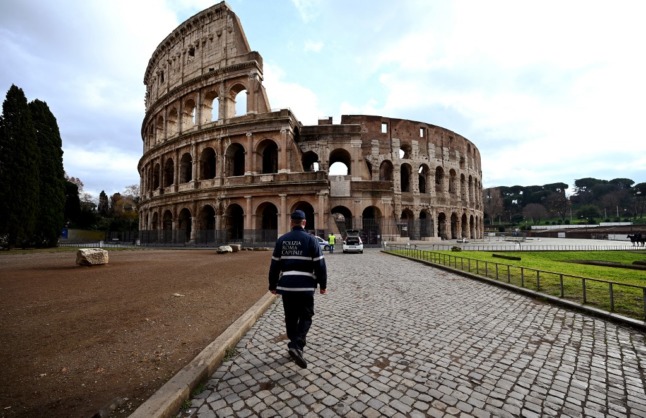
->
[129, 293, 277, 418]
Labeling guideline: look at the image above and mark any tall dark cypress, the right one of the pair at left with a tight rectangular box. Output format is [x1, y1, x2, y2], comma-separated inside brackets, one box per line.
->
[29, 100, 65, 247]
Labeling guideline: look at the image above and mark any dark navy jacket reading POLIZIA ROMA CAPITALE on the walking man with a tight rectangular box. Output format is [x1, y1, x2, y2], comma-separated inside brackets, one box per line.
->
[269, 227, 327, 294]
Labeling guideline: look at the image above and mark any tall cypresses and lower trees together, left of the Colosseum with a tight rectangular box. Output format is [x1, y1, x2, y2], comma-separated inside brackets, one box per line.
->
[0, 85, 139, 248]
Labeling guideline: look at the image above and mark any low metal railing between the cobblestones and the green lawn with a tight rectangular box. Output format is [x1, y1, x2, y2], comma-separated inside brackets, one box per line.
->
[385, 245, 646, 321]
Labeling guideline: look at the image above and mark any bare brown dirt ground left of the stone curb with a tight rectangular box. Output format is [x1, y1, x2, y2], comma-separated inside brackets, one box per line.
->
[0, 249, 271, 418]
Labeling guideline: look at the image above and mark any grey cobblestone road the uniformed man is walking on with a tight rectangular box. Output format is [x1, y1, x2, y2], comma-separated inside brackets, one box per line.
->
[183, 250, 646, 418]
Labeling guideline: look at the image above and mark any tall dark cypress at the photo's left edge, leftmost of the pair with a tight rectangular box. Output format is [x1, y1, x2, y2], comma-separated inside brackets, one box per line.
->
[0, 85, 39, 248]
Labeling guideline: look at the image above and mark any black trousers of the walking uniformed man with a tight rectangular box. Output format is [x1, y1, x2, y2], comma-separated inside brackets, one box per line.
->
[282, 292, 314, 350]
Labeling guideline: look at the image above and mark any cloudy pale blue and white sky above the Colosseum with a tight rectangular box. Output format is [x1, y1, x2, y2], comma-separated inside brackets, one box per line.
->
[0, 0, 646, 197]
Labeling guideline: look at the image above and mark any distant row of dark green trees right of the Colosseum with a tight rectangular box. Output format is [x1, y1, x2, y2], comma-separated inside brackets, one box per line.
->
[483, 177, 646, 225]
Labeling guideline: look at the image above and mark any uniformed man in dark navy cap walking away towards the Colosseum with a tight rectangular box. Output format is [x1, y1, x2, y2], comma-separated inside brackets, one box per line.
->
[269, 210, 327, 369]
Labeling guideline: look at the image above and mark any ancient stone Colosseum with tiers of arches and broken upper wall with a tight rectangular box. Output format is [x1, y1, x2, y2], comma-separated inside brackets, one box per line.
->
[138, 2, 483, 245]
